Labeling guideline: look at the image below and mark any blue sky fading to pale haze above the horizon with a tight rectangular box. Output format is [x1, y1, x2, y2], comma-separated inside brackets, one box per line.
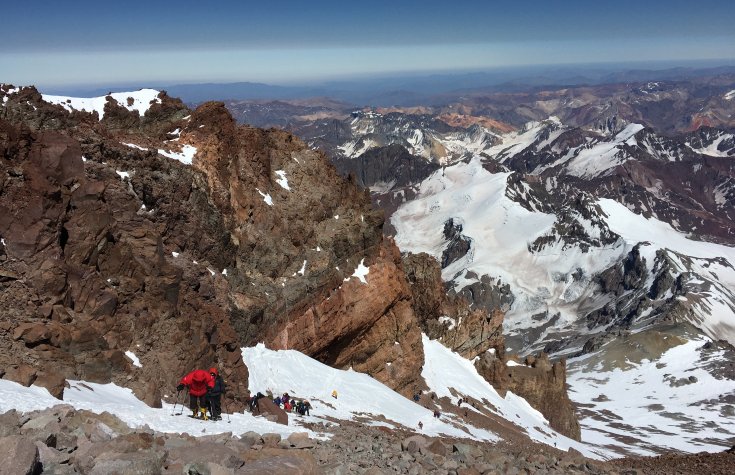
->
[0, 0, 735, 86]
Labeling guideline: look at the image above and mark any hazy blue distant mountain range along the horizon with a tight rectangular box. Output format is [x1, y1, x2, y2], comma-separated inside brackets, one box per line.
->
[45, 61, 735, 106]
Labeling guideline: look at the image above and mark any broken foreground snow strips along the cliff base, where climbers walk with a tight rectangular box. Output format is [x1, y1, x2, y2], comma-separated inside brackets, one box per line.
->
[0, 336, 610, 458]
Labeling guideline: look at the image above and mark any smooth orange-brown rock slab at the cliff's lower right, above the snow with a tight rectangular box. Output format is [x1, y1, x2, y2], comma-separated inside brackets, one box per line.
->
[266, 240, 424, 394]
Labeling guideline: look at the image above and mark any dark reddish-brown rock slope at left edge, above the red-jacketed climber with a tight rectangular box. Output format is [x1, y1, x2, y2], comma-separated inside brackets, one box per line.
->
[0, 117, 247, 405]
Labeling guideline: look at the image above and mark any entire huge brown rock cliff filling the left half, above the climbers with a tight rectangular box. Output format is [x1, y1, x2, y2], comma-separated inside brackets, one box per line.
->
[0, 88, 434, 404]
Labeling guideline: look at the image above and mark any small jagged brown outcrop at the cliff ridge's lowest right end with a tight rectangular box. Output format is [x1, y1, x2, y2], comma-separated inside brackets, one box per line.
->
[475, 353, 581, 440]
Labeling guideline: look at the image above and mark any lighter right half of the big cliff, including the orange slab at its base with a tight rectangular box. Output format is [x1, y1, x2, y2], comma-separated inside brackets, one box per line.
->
[181, 103, 423, 390]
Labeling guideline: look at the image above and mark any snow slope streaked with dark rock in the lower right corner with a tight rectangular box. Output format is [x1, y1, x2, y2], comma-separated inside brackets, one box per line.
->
[568, 334, 735, 455]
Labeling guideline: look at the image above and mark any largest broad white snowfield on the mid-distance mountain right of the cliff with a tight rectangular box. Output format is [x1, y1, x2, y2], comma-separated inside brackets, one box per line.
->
[391, 157, 625, 344]
